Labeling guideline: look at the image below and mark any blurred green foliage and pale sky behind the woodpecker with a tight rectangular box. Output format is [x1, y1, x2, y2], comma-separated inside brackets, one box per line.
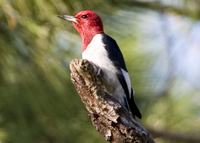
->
[0, 0, 200, 143]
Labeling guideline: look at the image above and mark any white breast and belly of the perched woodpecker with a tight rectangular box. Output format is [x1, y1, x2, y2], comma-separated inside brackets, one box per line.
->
[82, 34, 119, 94]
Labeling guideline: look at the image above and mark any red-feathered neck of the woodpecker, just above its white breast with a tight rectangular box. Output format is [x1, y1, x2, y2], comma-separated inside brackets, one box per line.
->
[81, 30, 103, 52]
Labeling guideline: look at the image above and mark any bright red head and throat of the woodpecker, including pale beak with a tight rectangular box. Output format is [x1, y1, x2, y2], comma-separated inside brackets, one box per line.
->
[59, 10, 103, 51]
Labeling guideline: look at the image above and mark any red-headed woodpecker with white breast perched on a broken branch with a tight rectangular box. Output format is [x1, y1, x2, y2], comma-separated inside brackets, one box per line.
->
[57, 10, 142, 118]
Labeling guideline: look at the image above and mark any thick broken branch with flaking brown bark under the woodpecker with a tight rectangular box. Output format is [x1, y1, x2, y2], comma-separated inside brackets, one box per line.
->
[70, 59, 154, 143]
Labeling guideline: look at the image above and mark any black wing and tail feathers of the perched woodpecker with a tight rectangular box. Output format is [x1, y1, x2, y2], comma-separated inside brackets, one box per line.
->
[102, 34, 141, 118]
